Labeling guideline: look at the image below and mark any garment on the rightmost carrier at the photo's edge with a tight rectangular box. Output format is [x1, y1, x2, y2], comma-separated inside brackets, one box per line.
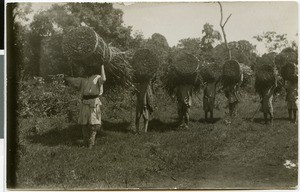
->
[286, 82, 298, 110]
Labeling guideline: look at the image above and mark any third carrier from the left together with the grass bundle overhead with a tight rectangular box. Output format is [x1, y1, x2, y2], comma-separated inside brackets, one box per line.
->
[162, 51, 203, 129]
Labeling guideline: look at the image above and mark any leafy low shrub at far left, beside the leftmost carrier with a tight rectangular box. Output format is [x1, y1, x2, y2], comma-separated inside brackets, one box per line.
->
[17, 76, 79, 118]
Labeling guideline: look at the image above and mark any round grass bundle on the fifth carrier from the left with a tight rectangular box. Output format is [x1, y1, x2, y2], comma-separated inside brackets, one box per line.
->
[222, 60, 241, 87]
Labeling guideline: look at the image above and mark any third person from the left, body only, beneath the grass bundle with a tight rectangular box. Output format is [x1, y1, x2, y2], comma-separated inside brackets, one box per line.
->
[175, 84, 193, 128]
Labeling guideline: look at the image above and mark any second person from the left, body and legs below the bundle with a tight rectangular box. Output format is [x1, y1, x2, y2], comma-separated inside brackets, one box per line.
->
[135, 82, 153, 133]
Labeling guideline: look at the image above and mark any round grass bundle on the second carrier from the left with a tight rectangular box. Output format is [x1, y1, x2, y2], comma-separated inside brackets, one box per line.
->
[131, 49, 159, 82]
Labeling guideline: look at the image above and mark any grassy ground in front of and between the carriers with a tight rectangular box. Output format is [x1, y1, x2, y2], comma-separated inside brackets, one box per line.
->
[16, 92, 298, 189]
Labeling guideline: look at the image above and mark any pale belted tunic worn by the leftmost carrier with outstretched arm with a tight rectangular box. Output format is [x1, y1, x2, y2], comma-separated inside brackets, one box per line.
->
[66, 75, 104, 125]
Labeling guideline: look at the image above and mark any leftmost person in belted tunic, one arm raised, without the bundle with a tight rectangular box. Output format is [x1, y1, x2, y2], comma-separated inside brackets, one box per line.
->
[65, 65, 106, 148]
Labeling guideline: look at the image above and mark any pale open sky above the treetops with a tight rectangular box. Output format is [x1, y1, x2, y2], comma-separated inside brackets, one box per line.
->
[27, 1, 298, 54]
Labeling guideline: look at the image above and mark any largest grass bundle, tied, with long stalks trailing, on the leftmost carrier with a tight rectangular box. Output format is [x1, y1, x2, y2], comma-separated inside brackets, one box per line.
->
[62, 26, 133, 88]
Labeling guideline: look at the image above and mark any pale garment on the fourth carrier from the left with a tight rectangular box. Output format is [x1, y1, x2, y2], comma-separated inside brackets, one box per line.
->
[203, 82, 216, 111]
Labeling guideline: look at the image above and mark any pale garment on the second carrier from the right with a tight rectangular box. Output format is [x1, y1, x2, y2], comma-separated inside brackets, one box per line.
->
[260, 85, 276, 115]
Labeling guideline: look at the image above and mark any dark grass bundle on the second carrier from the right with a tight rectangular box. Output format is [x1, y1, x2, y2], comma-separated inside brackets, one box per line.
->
[255, 64, 276, 94]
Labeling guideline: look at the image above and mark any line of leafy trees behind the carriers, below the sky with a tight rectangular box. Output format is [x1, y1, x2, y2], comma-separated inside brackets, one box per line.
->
[13, 3, 298, 78]
